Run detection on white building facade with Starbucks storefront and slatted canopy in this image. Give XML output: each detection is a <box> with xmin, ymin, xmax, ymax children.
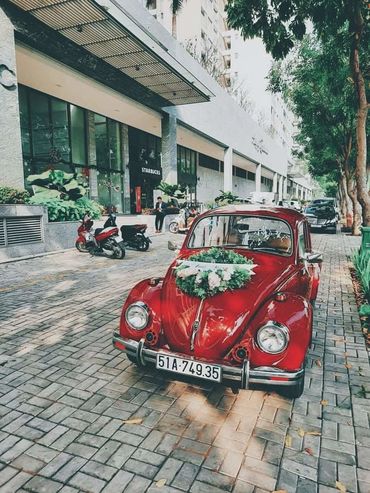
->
<box><xmin>0</xmin><ymin>0</ymin><xmax>312</xmax><ymax>213</ymax></box>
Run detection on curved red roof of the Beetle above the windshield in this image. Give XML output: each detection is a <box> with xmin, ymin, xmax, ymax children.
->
<box><xmin>202</xmin><ymin>204</ymin><xmax>305</xmax><ymax>226</ymax></box>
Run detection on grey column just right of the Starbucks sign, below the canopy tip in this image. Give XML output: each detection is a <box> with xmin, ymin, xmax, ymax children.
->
<box><xmin>162</xmin><ymin>113</ymin><xmax>177</xmax><ymax>185</ymax></box>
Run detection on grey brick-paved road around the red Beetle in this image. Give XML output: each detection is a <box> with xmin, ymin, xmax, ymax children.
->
<box><xmin>0</xmin><ymin>235</ymin><xmax>370</xmax><ymax>493</ymax></box>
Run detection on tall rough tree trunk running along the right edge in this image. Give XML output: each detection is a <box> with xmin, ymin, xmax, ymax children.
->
<box><xmin>349</xmin><ymin>0</ymin><xmax>370</xmax><ymax>226</ymax></box>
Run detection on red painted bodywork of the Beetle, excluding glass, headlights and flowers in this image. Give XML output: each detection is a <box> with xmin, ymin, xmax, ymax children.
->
<box><xmin>115</xmin><ymin>206</ymin><xmax>320</xmax><ymax>394</ymax></box>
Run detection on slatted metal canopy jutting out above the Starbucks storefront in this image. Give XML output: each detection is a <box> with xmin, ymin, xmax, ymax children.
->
<box><xmin>10</xmin><ymin>0</ymin><xmax>211</xmax><ymax>105</ymax></box>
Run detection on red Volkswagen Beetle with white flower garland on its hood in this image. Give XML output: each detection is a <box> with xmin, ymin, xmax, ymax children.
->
<box><xmin>113</xmin><ymin>205</ymin><xmax>322</xmax><ymax>397</ymax></box>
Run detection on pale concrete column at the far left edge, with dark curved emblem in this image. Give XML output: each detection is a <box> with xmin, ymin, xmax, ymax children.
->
<box><xmin>0</xmin><ymin>8</ymin><xmax>24</xmax><ymax>189</ymax></box>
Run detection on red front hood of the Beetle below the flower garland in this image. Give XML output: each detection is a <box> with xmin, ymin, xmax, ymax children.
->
<box><xmin>161</xmin><ymin>254</ymin><xmax>294</xmax><ymax>360</ymax></box>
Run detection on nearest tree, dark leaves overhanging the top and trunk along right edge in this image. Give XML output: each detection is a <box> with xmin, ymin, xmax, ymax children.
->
<box><xmin>226</xmin><ymin>0</ymin><xmax>370</xmax><ymax>226</ymax></box>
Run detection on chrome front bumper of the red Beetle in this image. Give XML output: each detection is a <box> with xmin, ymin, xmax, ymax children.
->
<box><xmin>113</xmin><ymin>332</ymin><xmax>304</xmax><ymax>389</ymax></box>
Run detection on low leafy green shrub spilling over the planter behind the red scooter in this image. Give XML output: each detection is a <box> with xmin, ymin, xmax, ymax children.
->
<box><xmin>30</xmin><ymin>194</ymin><xmax>104</xmax><ymax>222</ymax></box>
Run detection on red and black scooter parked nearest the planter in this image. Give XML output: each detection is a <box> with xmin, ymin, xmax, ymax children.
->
<box><xmin>75</xmin><ymin>214</ymin><xmax>125</xmax><ymax>259</ymax></box>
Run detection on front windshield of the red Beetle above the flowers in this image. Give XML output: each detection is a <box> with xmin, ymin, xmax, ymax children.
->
<box><xmin>188</xmin><ymin>214</ymin><xmax>293</xmax><ymax>255</ymax></box>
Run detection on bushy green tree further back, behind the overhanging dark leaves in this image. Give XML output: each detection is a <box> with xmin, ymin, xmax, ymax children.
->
<box><xmin>269</xmin><ymin>33</ymin><xmax>361</xmax><ymax>234</ymax></box>
